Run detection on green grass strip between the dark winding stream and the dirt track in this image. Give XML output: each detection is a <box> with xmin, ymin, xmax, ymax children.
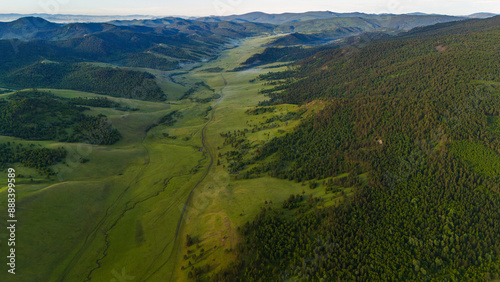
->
<box><xmin>65</xmin><ymin>140</ymin><xmax>208</xmax><ymax>280</ymax></box>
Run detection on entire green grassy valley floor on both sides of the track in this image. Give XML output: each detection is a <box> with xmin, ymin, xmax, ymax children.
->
<box><xmin>0</xmin><ymin>34</ymin><xmax>349</xmax><ymax>281</ymax></box>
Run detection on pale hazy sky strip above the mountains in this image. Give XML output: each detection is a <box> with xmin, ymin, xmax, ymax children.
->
<box><xmin>0</xmin><ymin>0</ymin><xmax>500</xmax><ymax>16</ymax></box>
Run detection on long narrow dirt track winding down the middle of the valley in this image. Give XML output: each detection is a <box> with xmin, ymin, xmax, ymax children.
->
<box><xmin>143</xmin><ymin>73</ymin><xmax>227</xmax><ymax>281</ymax></box>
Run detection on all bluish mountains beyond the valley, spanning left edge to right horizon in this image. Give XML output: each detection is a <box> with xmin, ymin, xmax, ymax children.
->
<box><xmin>0</xmin><ymin>11</ymin><xmax>496</xmax><ymax>97</ymax></box>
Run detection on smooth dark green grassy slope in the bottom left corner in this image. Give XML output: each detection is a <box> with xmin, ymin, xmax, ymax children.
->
<box><xmin>0</xmin><ymin>182</ymin><xmax>106</xmax><ymax>281</ymax></box>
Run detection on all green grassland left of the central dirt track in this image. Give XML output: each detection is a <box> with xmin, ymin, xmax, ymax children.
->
<box><xmin>0</xmin><ymin>81</ymin><xmax>207</xmax><ymax>281</ymax></box>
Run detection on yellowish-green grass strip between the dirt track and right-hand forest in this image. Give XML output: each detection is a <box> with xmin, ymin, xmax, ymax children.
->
<box><xmin>172</xmin><ymin>38</ymin><xmax>351</xmax><ymax>281</ymax></box>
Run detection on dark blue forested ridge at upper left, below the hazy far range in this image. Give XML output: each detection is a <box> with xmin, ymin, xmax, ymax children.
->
<box><xmin>1</xmin><ymin>19</ymin><xmax>228</xmax><ymax>65</ymax></box>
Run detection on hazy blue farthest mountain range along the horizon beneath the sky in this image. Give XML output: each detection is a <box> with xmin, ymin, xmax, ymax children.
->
<box><xmin>0</xmin><ymin>11</ymin><xmax>476</xmax><ymax>42</ymax></box>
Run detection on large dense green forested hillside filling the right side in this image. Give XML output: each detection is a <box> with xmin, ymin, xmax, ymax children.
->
<box><xmin>215</xmin><ymin>17</ymin><xmax>500</xmax><ymax>281</ymax></box>
